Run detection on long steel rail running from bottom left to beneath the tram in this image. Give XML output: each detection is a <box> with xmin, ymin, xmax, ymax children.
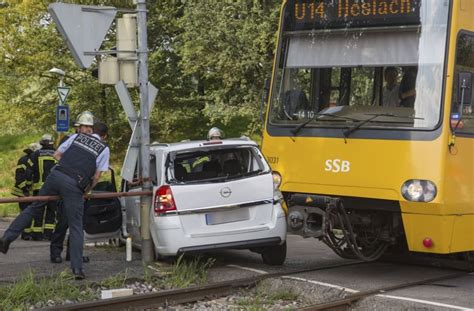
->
<box><xmin>44</xmin><ymin>261</ymin><xmax>367</xmax><ymax>311</ymax></box>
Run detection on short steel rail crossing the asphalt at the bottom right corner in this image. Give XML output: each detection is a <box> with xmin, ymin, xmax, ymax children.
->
<box><xmin>298</xmin><ymin>272</ymin><xmax>468</xmax><ymax>311</ymax></box>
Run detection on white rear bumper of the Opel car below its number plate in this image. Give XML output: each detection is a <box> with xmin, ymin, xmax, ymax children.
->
<box><xmin>150</xmin><ymin>203</ymin><xmax>286</xmax><ymax>256</ymax></box>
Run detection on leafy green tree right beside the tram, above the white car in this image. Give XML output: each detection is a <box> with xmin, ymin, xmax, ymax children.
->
<box><xmin>177</xmin><ymin>0</ymin><xmax>278</xmax><ymax>136</ymax></box>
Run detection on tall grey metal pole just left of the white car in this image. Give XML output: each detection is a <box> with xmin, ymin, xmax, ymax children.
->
<box><xmin>136</xmin><ymin>0</ymin><xmax>154</xmax><ymax>263</ymax></box>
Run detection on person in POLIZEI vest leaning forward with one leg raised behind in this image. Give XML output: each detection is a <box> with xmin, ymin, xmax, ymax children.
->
<box><xmin>0</xmin><ymin>113</ymin><xmax>110</xmax><ymax>280</ymax></box>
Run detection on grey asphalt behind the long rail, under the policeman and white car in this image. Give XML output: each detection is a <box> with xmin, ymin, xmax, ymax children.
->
<box><xmin>0</xmin><ymin>218</ymin><xmax>343</xmax><ymax>286</ymax></box>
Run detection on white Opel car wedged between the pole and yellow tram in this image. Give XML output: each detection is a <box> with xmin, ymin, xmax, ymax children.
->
<box><xmin>122</xmin><ymin>138</ymin><xmax>286</xmax><ymax>265</ymax></box>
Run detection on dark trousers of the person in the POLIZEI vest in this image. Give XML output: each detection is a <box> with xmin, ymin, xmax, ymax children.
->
<box><xmin>3</xmin><ymin>170</ymin><xmax>84</xmax><ymax>269</ymax></box>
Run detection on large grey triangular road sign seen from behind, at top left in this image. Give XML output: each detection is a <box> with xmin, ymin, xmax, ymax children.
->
<box><xmin>48</xmin><ymin>3</ymin><xmax>117</xmax><ymax>68</ymax></box>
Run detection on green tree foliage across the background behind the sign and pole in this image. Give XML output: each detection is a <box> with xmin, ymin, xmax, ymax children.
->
<box><xmin>0</xmin><ymin>0</ymin><xmax>280</xmax><ymax>147</ymax></box>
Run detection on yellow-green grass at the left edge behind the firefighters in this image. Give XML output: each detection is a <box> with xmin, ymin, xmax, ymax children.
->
<box><xmin>0</xmin><ymin>134</ymin><xmax>41</xmax><ymax>217</ymax></box>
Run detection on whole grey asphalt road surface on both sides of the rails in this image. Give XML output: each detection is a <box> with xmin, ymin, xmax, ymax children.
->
<box><xmin>0</xmin><ymin>219</ymin><xmax>474</xmax><ymax>310</ymax></box>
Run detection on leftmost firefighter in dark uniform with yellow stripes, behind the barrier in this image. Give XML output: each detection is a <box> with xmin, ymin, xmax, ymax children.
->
<box><xmin>11</xmin><ymin>143</ymin><xmax>41</xmax><ymax>240</ymax></box>
